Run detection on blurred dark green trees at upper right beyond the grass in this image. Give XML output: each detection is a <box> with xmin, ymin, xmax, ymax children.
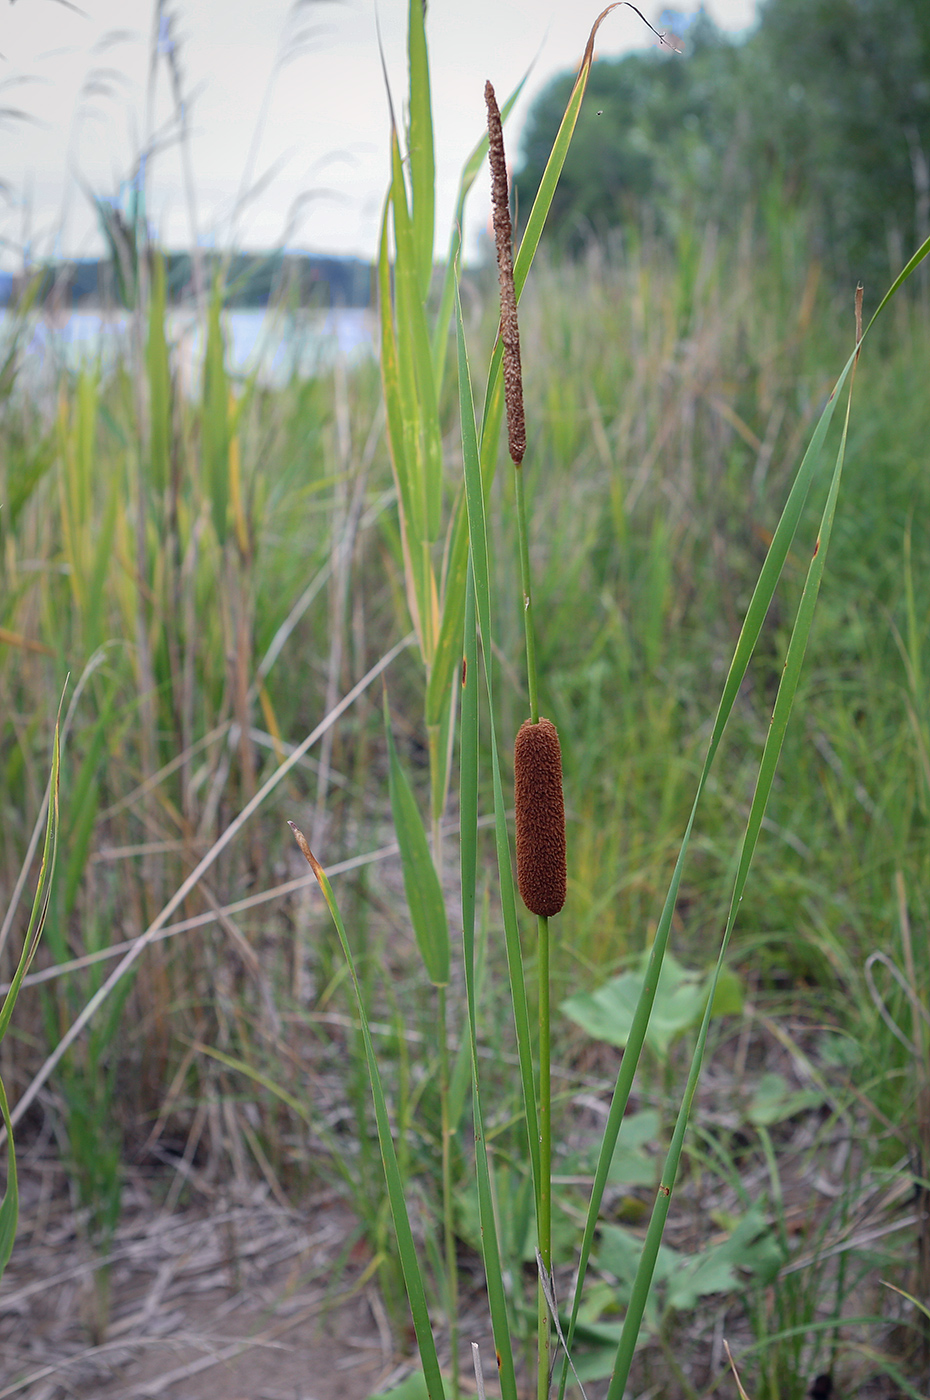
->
<box><xmin>515</xmin><ymin>0</ymin><xmax>930</xmax><ymax>279</ymax></box>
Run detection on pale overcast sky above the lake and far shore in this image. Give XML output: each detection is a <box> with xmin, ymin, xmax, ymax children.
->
<box><xmin>0</xmin><ymin>0</ymin><xmax>756</xmax><ymax>269</ymax></box>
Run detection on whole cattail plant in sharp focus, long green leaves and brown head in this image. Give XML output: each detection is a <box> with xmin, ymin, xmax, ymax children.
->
<box><xmin>291</xmin><ymin>0</ymin><xmax>930</xmax><ymax>1400</ymax></box>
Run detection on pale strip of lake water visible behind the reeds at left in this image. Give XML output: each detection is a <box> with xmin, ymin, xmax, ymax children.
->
<box><xmin>0</xmin><ymin>307</ymin><xmax>375</xmax><ymax>393</ymax></box>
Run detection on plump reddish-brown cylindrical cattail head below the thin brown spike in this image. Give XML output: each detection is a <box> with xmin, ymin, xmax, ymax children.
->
<box><xmin>514</xmin><ymin>718</ymin><xmax>566</xmax><ymax>918</ymax></box>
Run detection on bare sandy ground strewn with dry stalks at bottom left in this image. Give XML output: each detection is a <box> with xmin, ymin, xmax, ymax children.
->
<box><xmin>0</xmin><ymin>1162</ymin><xmax>409</xmax><ymax>1400</ymax></box>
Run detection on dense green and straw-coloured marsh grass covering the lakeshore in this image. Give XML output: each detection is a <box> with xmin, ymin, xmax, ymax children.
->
<box><xmin>0</xmin><ymin>3</ymin><xmax>930</xmax><ymax>1396</ymax></box>
